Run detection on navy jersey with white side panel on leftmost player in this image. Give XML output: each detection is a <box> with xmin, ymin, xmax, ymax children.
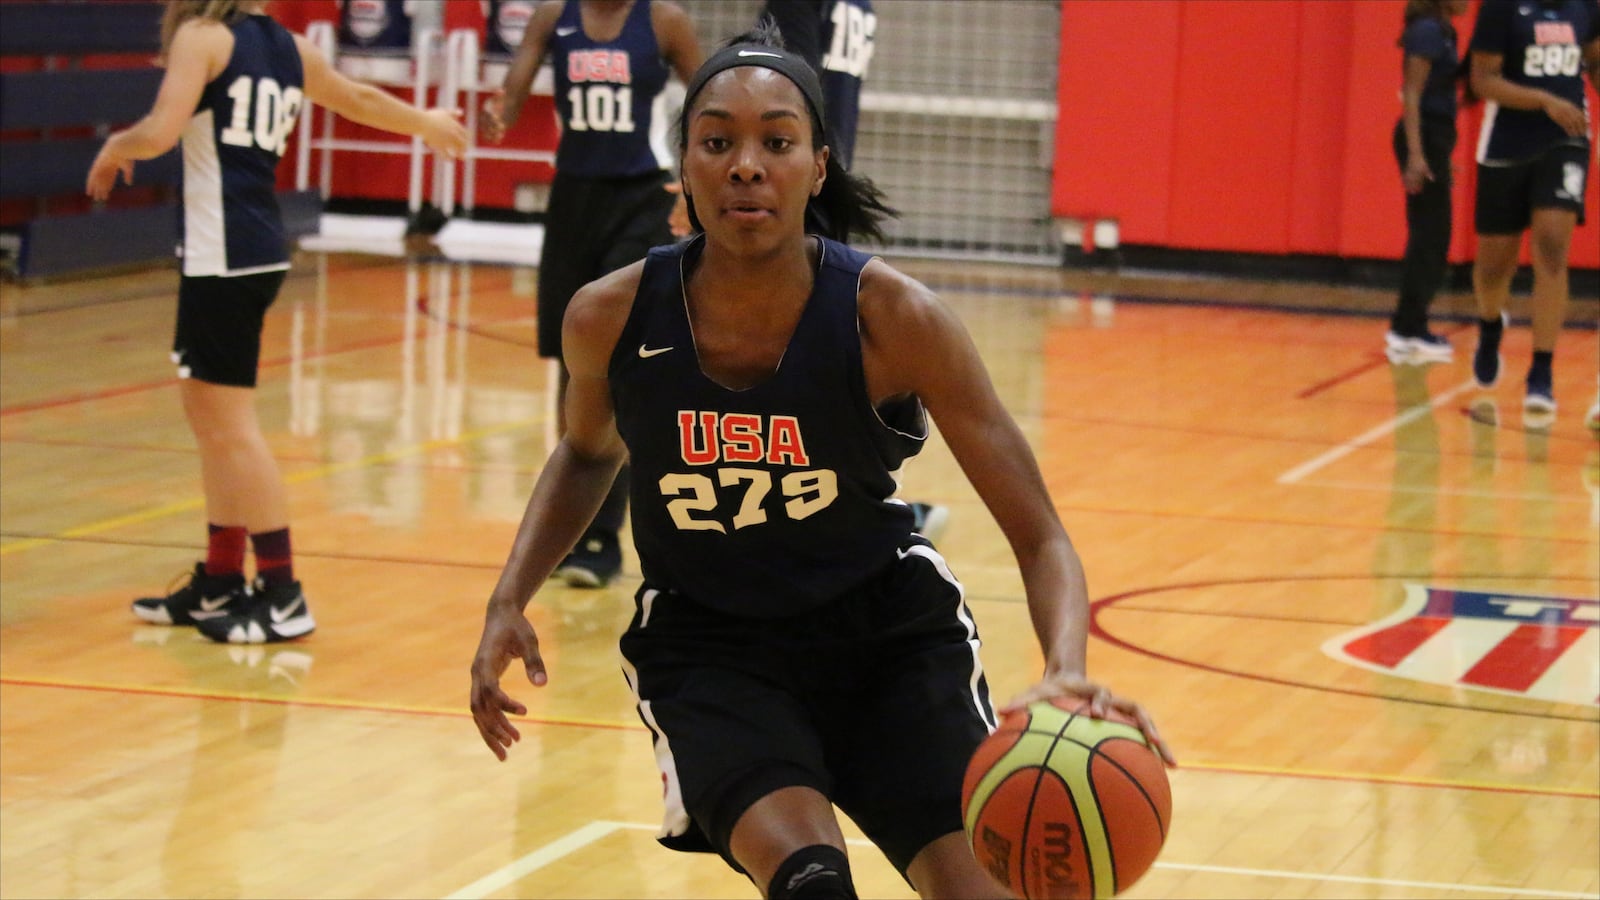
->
<box><xmin>182</xmin><ymin>16</ymin><xmax>306</xmax><ymax>275</ymax></box>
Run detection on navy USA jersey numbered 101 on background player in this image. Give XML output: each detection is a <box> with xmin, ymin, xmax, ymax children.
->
<box><xmin>550</xmin><ymin>0</ymin><xmax>672</xmax><ymax>178</ymax></box>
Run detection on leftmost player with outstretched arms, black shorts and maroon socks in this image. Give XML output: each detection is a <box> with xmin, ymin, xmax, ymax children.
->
<box><xmin>86</xmin><ymin>0</ymin><xmax>467</xmax><ymax>644</ymax></box>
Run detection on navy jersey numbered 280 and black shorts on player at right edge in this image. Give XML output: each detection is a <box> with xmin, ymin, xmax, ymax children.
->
<box><xmin>1470</xmin><ymin>0</ymin><xmax>1600</xmax><ymax>234</ymax></box>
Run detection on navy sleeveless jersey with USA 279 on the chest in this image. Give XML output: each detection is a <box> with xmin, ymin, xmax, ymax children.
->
<box><xmin>610</xmin><ymin>237</ymin><xmax>928</xmax><ymax>618</ymax></box>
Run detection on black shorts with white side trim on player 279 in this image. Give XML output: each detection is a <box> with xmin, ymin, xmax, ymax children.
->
<box><xmin>621</xmin><ymin>536</ymin><xmax>995</xmax><ymax>874</ymax></box>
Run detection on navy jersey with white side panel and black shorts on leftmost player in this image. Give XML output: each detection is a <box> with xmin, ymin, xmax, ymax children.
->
<box><xmin>173</xmin><ymin>16</ymin><xmax>306</xmax><ymax>386</ymax></box>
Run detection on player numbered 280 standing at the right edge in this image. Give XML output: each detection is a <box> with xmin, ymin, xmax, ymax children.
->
<box><xmin>1470</xmin><ymin>0</ymin><xmax>1600</xmax><ymax>424</ymax></box>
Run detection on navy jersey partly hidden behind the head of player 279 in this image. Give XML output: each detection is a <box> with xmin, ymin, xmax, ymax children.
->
<box><xmin>766</xmin><ymin>0</ymin><xmax>878</xmax><ymax>168</ymax></box>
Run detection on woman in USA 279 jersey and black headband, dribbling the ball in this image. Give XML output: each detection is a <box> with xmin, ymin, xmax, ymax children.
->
<box><xmin>472</xmin><ymin>30</ymin><xmax>1166</xmax><ymax>898</ymax></box>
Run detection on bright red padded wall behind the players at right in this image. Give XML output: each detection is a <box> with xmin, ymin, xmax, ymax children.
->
<box><xmin>1051</xmin><ymin>0</ymin><xmax>1600</xmax><ymax>269</ymax></box>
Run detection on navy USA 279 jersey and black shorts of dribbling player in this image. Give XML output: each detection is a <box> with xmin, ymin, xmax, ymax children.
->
<box><xmin>610</xmin><ymin>237</ymin><xmax>994</xmax><ymax>871</ymax></box>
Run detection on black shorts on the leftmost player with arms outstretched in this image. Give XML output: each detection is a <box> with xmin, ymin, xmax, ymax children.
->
<box><xmin>173</xmin><ymin>269</ymin><xmax>288</xmax><ymax>388</ymax></box>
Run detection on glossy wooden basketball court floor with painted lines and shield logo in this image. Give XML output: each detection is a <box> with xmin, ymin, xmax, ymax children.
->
<box><xmin>0</xmin><ymin>246</ymin><xmax>1600</xmax><ymax>898</ymax></box>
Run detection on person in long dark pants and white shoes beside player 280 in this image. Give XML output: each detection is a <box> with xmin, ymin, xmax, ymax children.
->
<box><xmin>1384</xmin><ymin>0</ymin><xmax>1467</xmax><ymax>362</ymax></box>
